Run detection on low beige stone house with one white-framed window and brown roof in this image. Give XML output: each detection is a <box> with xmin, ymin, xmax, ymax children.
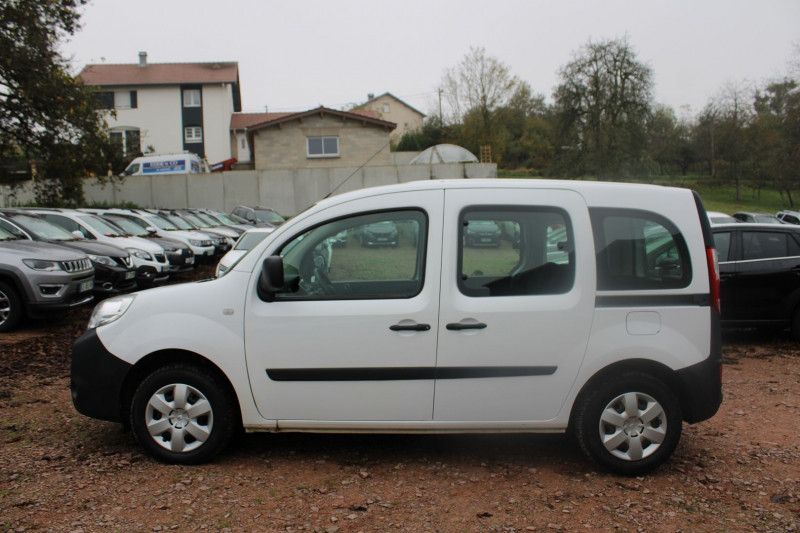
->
<box><xmin>231</xmin><ymin>107</ymin><xmax>397</xmax><ymax>170</ymax></box>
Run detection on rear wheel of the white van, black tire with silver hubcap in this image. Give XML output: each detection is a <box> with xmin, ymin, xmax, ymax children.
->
<box><xmin>574</xmin><ymin>372</ymin><xmax>682</xmax><ymax>476</ymax></box>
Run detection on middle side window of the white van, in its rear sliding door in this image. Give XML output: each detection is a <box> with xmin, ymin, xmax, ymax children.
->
<box><xmin>458</xmin><ymin>206</ymin><xmax>575</xmax><ymax>297</ymax></box>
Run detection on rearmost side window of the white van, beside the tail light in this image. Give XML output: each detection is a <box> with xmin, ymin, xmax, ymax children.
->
<box><xmin>591</xmin><ymin>209</ymin><xmax>692</xmax><ymax>290</ymax></box>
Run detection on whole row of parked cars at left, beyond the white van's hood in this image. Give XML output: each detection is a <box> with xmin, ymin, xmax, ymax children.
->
<box><xmin>0</xmin><ymin>208</ymin><xmax>282</xmax><ymax>332</ymax></box>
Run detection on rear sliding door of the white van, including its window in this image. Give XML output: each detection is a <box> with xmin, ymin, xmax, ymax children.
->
<box><xmin>434</xmin><ymin>189</ymin><xmax>595</xmax><ymax>427</ymax></box>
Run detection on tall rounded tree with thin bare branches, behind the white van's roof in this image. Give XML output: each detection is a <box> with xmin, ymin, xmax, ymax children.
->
<box><xmin>554</xmin><ymin>38</ymin><xmax>653</xmax><ymax>176</ymax></box>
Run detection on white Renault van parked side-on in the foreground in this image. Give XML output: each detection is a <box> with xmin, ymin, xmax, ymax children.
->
<box><xmin>72</xmin><ymin>180</ymin><xmax>722</xmax><ymax>474</ymax></box>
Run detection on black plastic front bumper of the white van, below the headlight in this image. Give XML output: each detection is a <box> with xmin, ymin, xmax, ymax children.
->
<box><xmin>70</xmin><ymin>329</ymin><xmax>132</xmax><ymax>422</ymax></box>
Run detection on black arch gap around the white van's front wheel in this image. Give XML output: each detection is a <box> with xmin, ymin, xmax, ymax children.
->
<box><xmin>119</xmin><ymin>349</ymin><xmax>242</xmax><ymax>426</ymax></box>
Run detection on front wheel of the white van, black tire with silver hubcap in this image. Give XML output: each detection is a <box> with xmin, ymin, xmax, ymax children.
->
<box><xmin>130</xmin><ymin>364</ymin><xmax>238</xmax><ymax>465</ymax></box>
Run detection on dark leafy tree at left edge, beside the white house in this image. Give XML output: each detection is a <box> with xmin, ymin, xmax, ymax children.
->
<box><xmin>0</xmin><ymin>0</ymin><xmax>121</xmax><ymax>203</ymax></box>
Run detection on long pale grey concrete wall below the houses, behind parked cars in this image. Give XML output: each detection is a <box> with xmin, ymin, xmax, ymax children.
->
<box><xmin>0</xmin><ymin>163</ymin><xmax>497</xmax><ymax>216</ymax></box>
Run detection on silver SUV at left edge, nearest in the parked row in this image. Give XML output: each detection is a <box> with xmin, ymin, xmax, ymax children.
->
<box><xmin>0</xmin><ymin>225</ymin><xmax>94</xmax><ymax>333</ymax></box>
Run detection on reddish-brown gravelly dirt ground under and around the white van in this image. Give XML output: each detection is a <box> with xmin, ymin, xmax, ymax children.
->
<box><xmin>0</xmin><ymin>268</ymin><xmax>800</xmax><ymax>533</ymax></box>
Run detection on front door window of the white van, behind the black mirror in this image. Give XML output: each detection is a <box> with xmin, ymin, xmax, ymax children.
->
<box><xmin>276</xmin><ymin>210</ymin><xmax>427</xmax><ymax>300</ymax></box>
